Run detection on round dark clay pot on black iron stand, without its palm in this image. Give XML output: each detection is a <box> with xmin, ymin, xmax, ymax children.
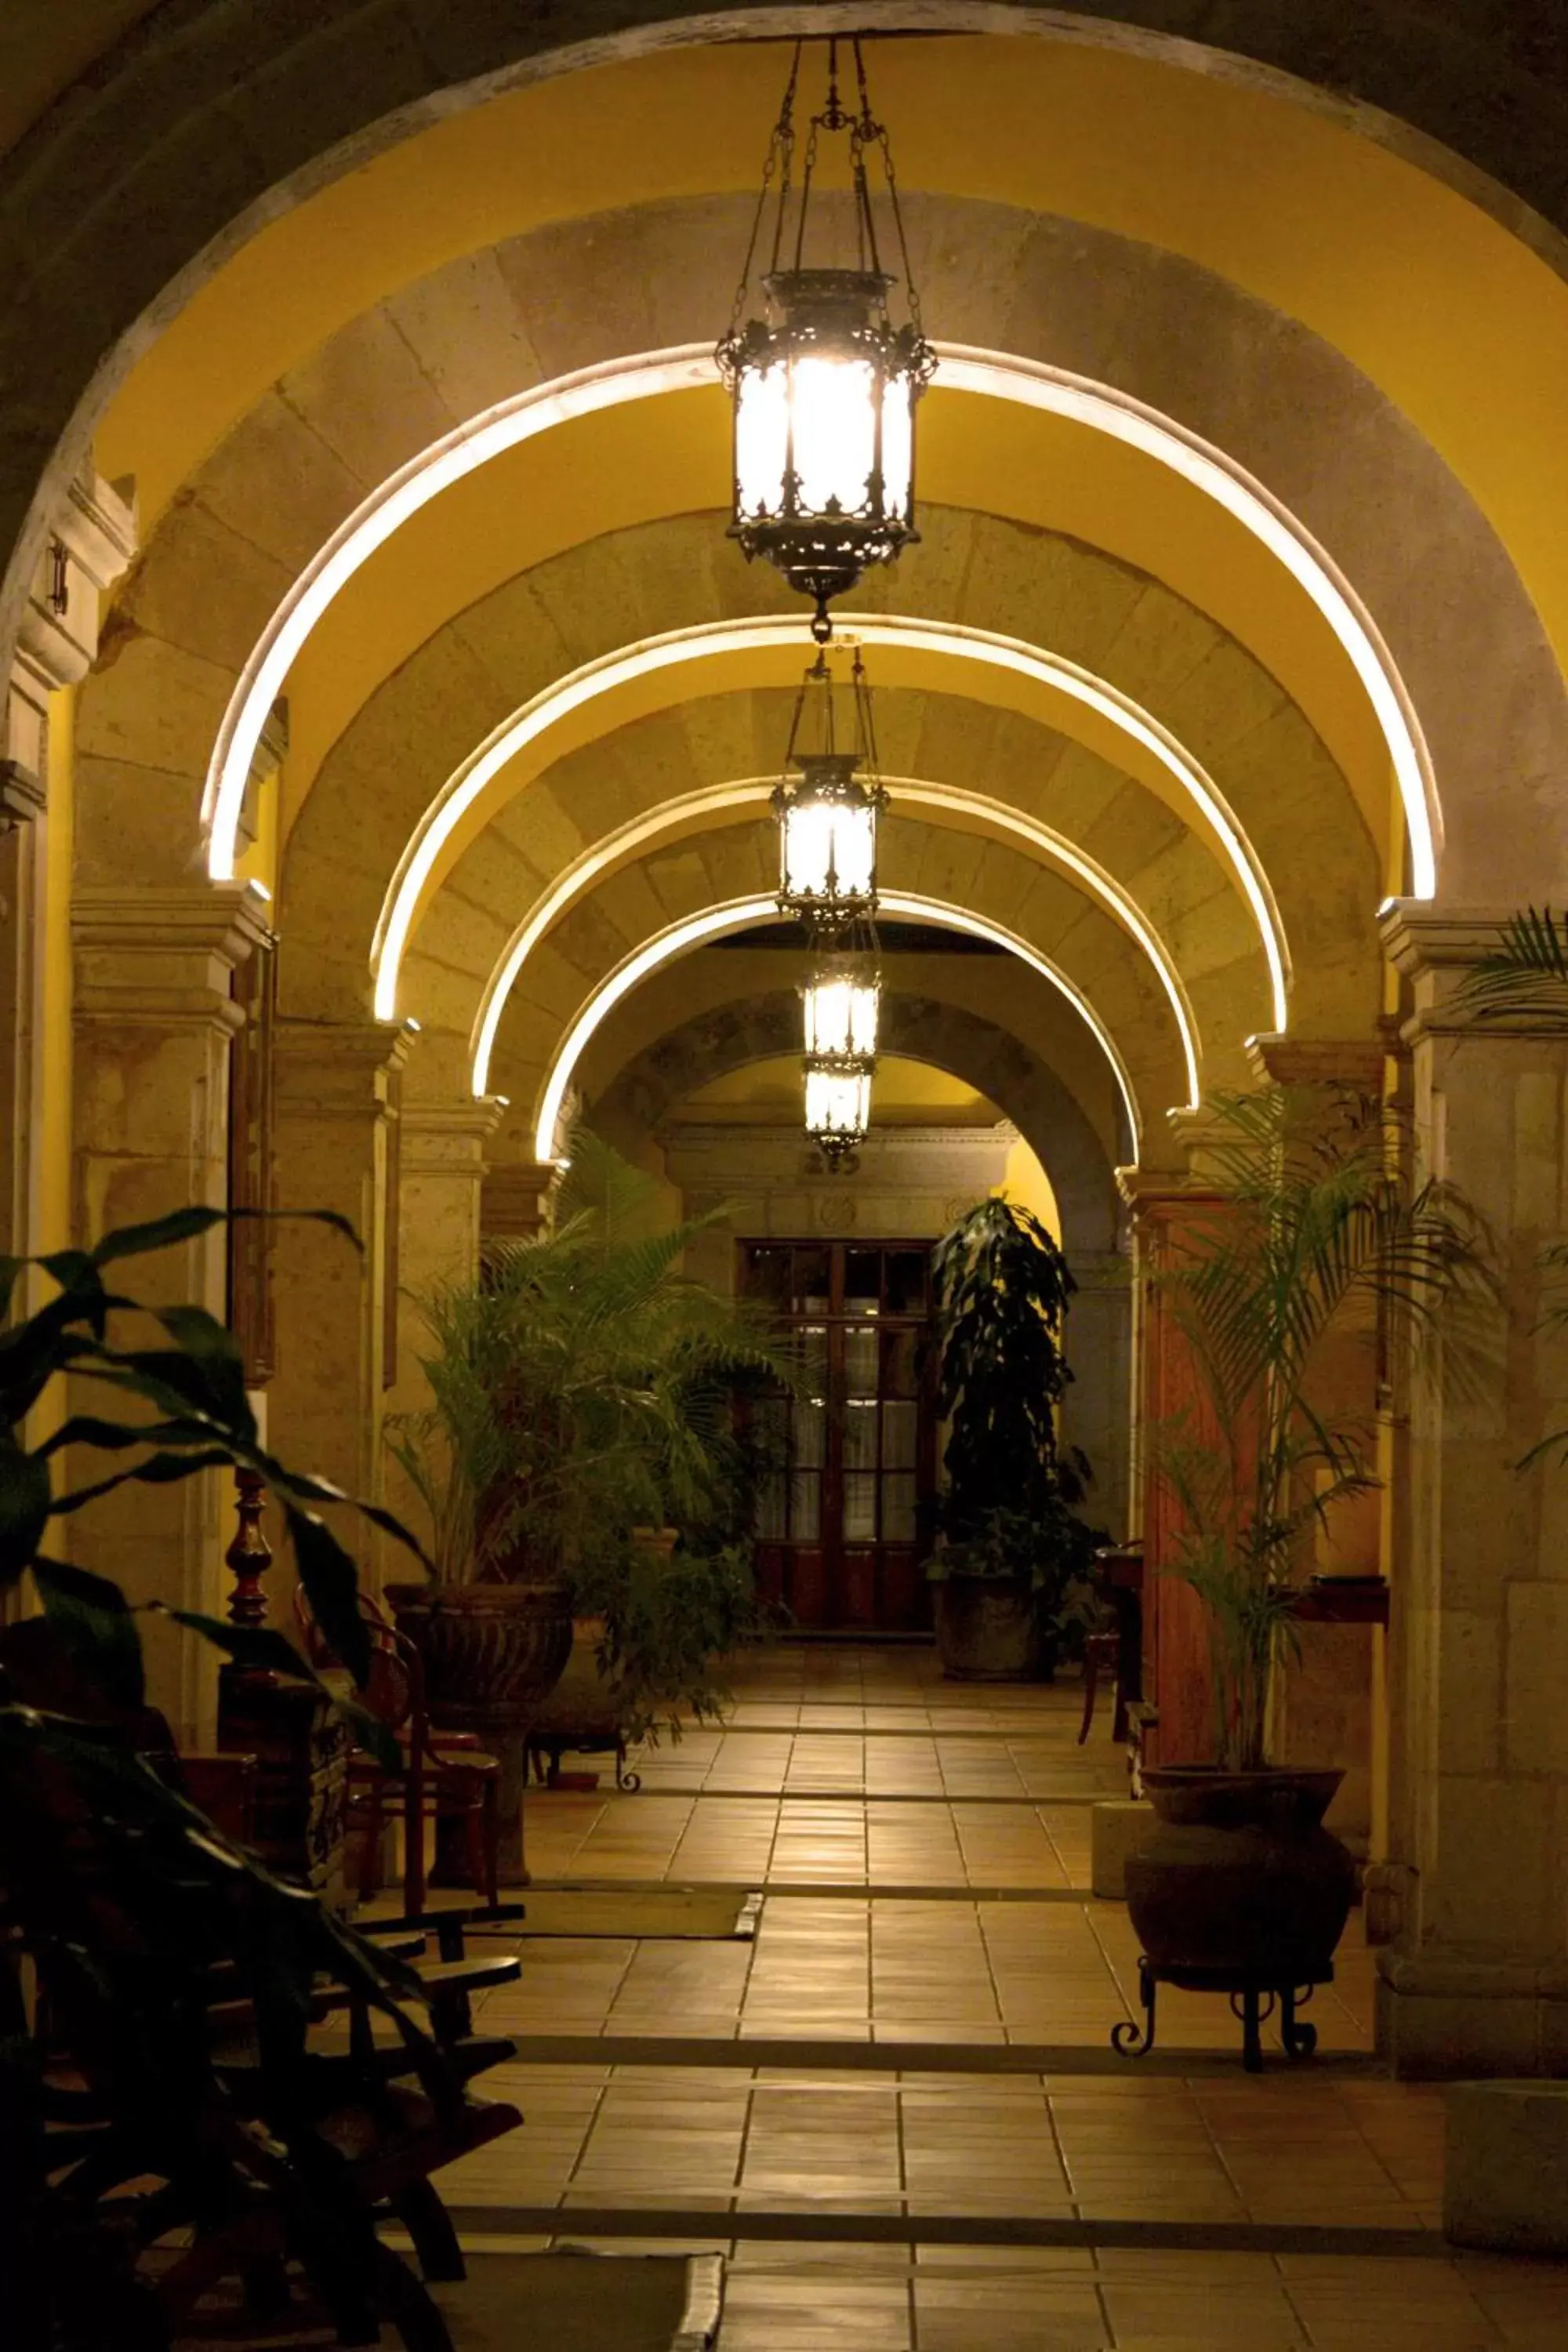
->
<box><xmin>1126</xmin><ymin>1764</ymin><xmax>1356</xmax><ymax>1987</ymax></box>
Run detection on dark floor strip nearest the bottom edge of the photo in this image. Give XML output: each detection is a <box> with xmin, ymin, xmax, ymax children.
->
<box><xmin>452</xmin><ymin>2206</ymin><xmax>1453</xmax><ymax>2260</ymax></box>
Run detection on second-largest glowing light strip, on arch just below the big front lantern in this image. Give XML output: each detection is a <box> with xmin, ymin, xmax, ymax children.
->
<box><xmin>372</xmin><ymin>614</ymin><xmax>1290</xmax><ymax>1030</ymax></box>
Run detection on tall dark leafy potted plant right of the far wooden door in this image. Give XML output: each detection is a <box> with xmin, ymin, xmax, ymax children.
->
<box><xmin>926</xmin><ymin>1200</ymin><xmax>1105</xmax><ymax>1682</ymax></box>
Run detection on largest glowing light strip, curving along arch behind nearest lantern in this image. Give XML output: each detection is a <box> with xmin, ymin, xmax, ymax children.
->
<box><xmin>202</xmin><ymin>343</ymin><xmax>1441</xmax><ymax>898</ymax></box>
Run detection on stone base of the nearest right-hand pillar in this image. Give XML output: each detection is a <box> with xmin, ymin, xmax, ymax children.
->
<box><xmin>1377</xmin><ymin>1950</ymin><xmax>1568</xmax><ymax>2082</ymax></box>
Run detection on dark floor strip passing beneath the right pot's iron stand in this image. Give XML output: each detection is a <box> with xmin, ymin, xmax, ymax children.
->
<box><xmin>493</xmin><ymin>2032</ymin><xmax>1385</xmax><ymax>2084</ymax></box>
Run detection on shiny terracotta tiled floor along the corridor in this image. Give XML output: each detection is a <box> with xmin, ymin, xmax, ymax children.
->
<box><xmin>423</xmin><ymin>1646</ymin><xmax>1568</xmax><ymax>2352</ymax></box>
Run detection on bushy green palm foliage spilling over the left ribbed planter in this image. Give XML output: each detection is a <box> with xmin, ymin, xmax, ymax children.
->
<box><xmin>388</xmin><ymin>1134</ymin><xmax>787</xmax><ymax>1790</ymax></box>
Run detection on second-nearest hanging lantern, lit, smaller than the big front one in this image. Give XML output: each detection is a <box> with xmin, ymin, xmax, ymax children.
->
<box><xmin>774</xmin><ymin>652</ymin><xmax>886</xmax><ymax>938</ymax></box>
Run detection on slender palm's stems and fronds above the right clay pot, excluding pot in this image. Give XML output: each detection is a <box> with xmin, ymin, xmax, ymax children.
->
<box><xmin>1149</xmin><ymin>1087</ymin><xmax>1493</xmax><ymax>1771</ymax></box>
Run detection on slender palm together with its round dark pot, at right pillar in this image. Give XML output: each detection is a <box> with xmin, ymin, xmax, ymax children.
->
<box><xmin>1126</xmin><ymin>1087</ymin><xmax>1488</xmax><ymax>1987</ymax></box>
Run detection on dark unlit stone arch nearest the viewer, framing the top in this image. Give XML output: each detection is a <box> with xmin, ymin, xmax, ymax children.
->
<box><xmin>0</xmin><ymin>0</ymin><xmax>1568</xmax><ymax>673</ymax></box>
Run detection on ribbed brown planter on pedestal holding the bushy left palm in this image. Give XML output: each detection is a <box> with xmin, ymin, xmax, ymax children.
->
<box><xmin>386</xmin><ymin>1583</ymin><xmax>572</xmax><ymax>1886</ymax></box>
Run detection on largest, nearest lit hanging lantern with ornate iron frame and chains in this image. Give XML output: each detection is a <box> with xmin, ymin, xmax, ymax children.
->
<box><xmin>717</xmin><ymin>40</ymin><xmax>935</xmax><ymax>642</ymax></box>
